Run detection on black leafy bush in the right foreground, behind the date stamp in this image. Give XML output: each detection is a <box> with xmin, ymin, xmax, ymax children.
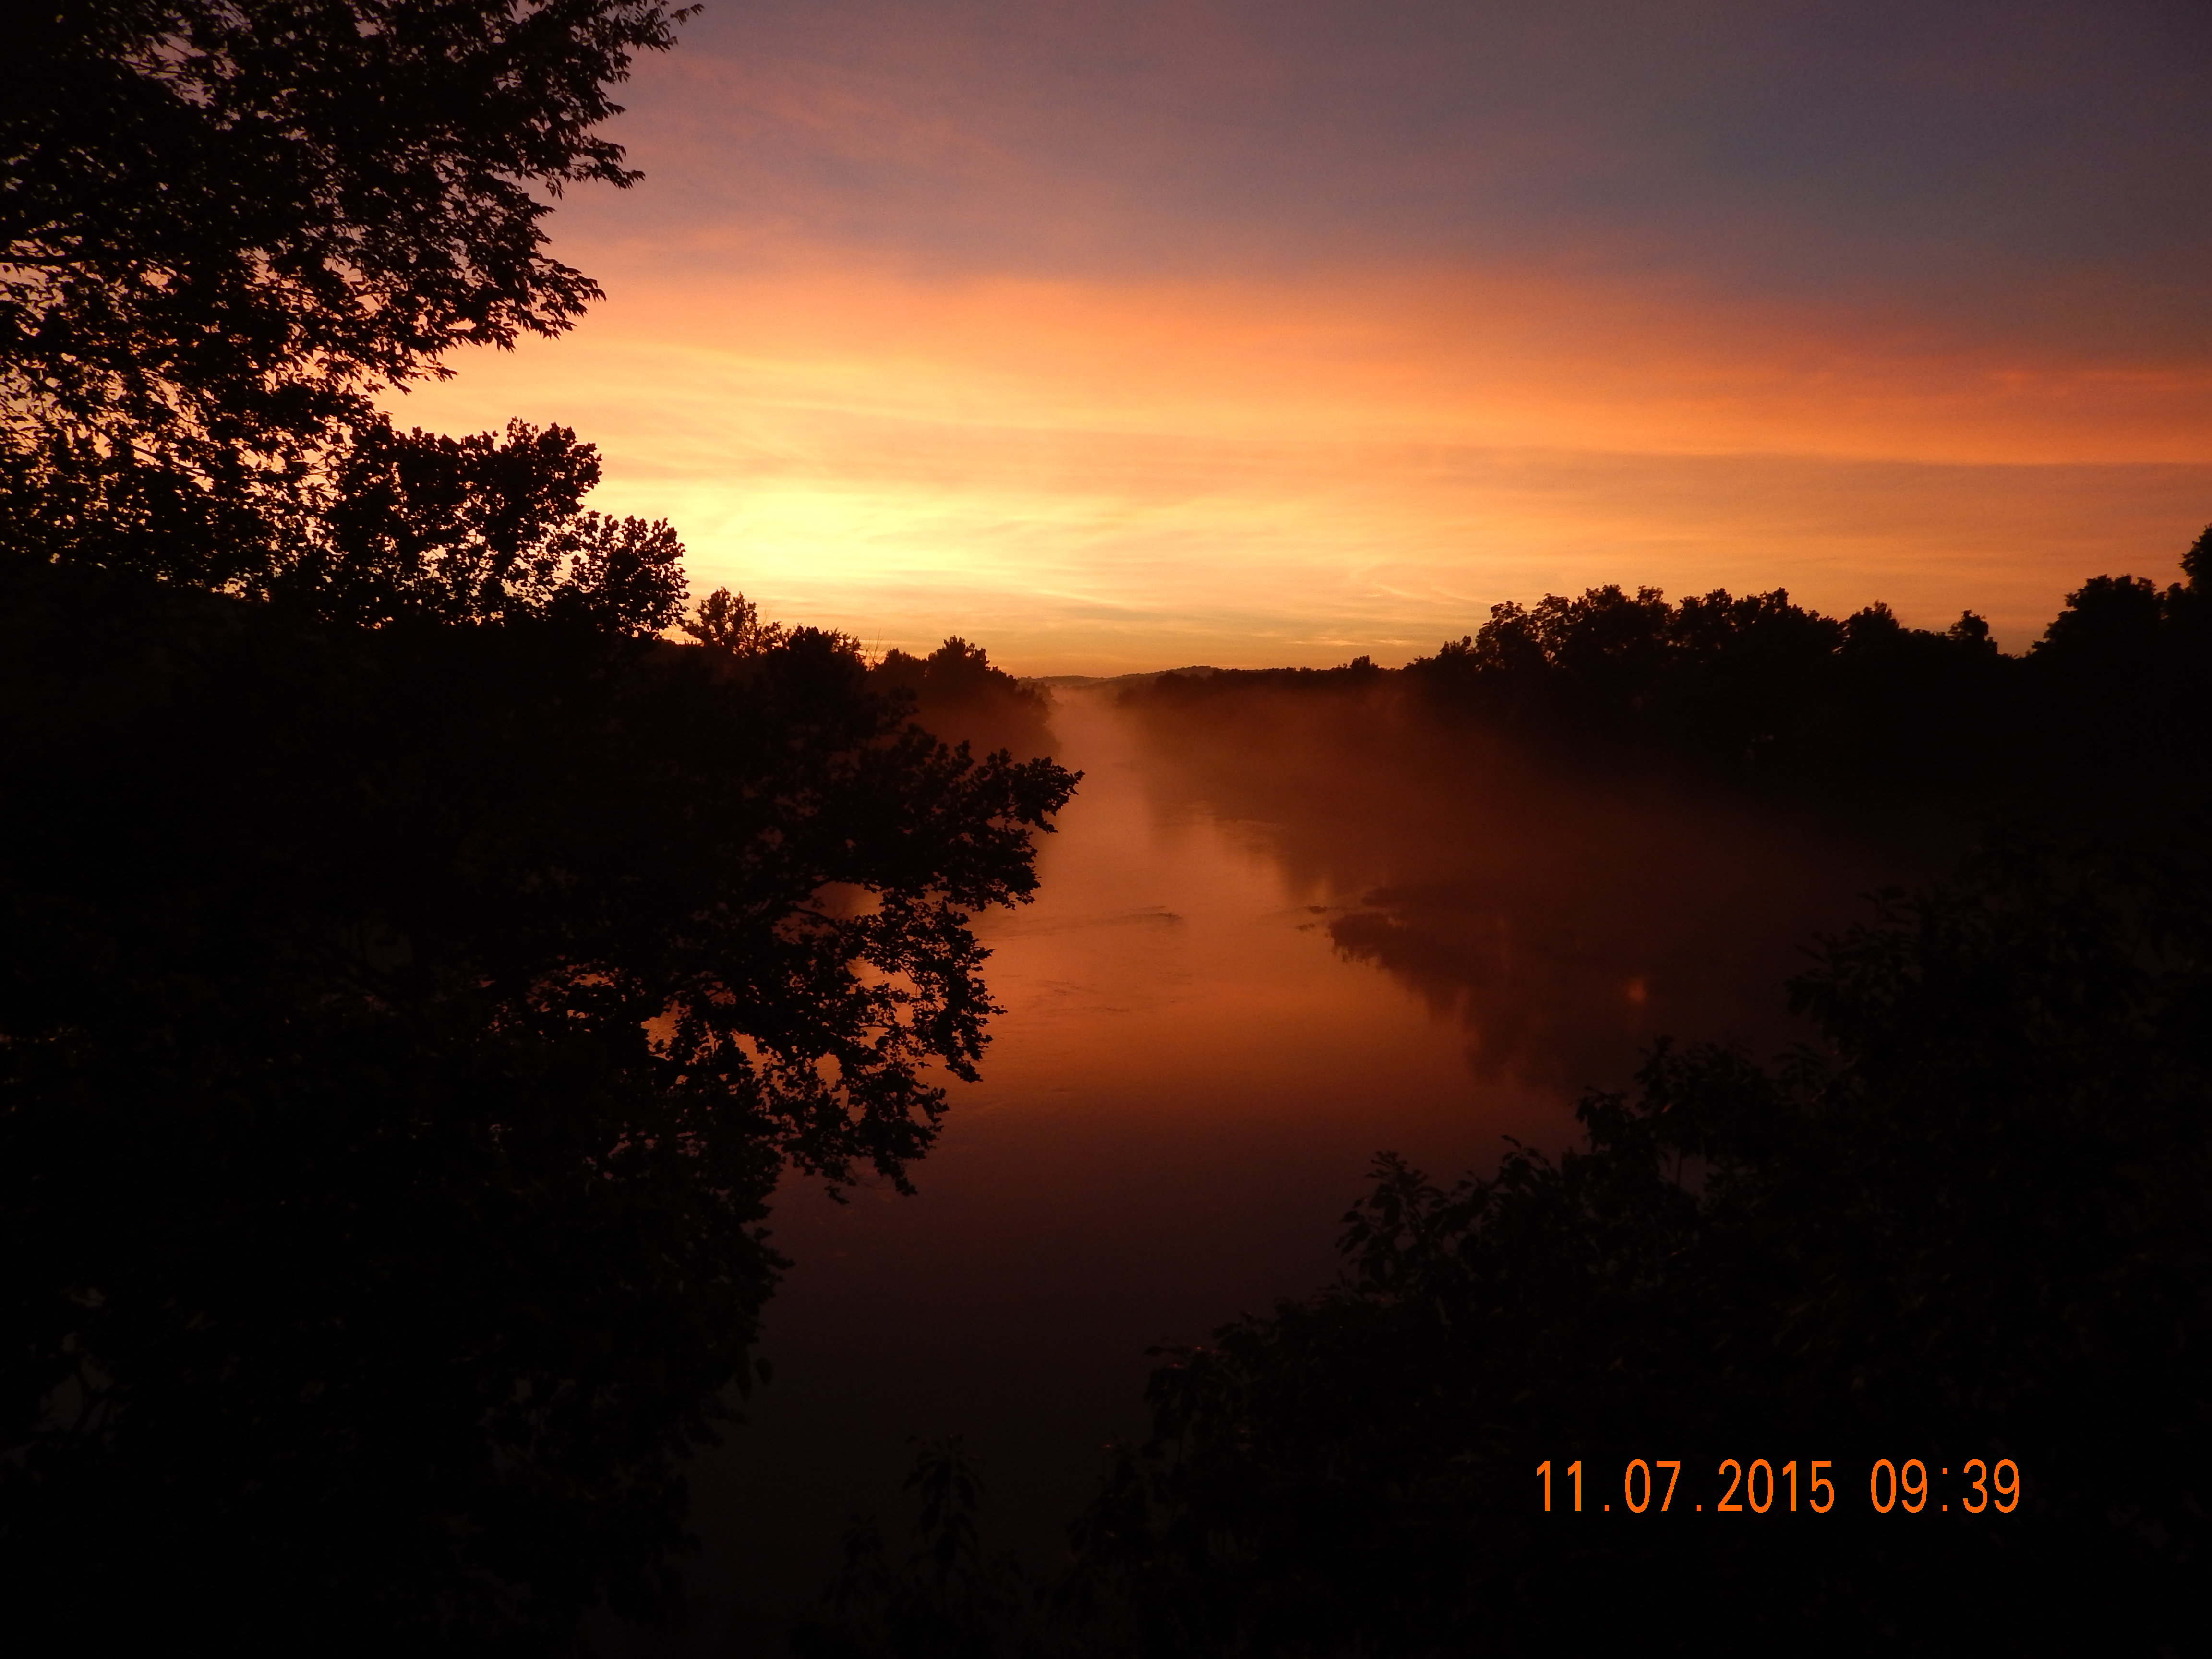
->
<box><xmin>1077</xmin><ymin>832</ymin><xmax>2212</xmax><ymax>1657</ymax></box>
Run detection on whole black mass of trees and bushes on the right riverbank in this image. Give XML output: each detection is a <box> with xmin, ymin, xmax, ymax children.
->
<box><xmin>796</xmin><ymin>570</ymin><xmax>2212</xmax><ymax>1659</ymax></box>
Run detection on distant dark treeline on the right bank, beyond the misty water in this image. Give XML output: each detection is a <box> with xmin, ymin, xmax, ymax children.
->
<box><xmin>1126</xmin><ymin>559</ymin><xmax>2212</xmax><ymax>807</ymax></box>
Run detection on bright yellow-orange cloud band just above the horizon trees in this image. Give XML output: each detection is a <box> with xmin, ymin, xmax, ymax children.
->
<box><xmin>398</xmin><ymin>261</ymin><xmax>2212</xmax><ymax>673</ymax></box>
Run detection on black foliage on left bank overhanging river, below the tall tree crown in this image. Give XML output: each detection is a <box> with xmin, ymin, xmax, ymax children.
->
<box><xmin>0</xmin><ymin>564</ymin><xmax>1070</xmax><ymax>1652</ymax></box>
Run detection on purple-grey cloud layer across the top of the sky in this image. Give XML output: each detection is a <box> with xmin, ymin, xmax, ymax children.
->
<box><xmin>588</xmin><ymin>0</ymin><xmax>2212</xmax><ymax>345</ymax></box>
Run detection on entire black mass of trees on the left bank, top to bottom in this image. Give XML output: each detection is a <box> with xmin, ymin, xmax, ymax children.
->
<box><xmin>0</xmin><ymin>0</ymin><xmax>1073</xmax><ymax>1655</ymax></box>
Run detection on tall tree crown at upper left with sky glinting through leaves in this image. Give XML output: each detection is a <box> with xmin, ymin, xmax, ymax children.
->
<box><xmin>0</xmin><ymin>0</ymin><xmax>684</xmax><ymax>589</ymax></box>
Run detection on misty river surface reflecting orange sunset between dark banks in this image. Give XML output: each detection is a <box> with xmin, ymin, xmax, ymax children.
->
<box><xmin>668</xmin><ymin>695</ymin><xmax>1937</xmax><ymax>1636</ymax></box>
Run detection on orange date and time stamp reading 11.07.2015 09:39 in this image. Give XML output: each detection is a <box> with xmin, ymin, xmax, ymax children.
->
<box><xmin>1535</xmin><ymin>1458</ymin><xmax>2020</xmax><ymax>1515</ymax></box>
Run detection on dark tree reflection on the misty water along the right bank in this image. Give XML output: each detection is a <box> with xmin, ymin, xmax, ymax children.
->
<box><xmin>1115</xmin><ymin>690</ymin><xmax>1955</xmax><ymax>1097</ymax></box>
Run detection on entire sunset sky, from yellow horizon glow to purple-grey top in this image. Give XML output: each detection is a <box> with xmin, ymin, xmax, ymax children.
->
<box><xmin>394</xmin><ymin>0</ymin><xmax>2212</xmax><ymax>674</ymax></box>
